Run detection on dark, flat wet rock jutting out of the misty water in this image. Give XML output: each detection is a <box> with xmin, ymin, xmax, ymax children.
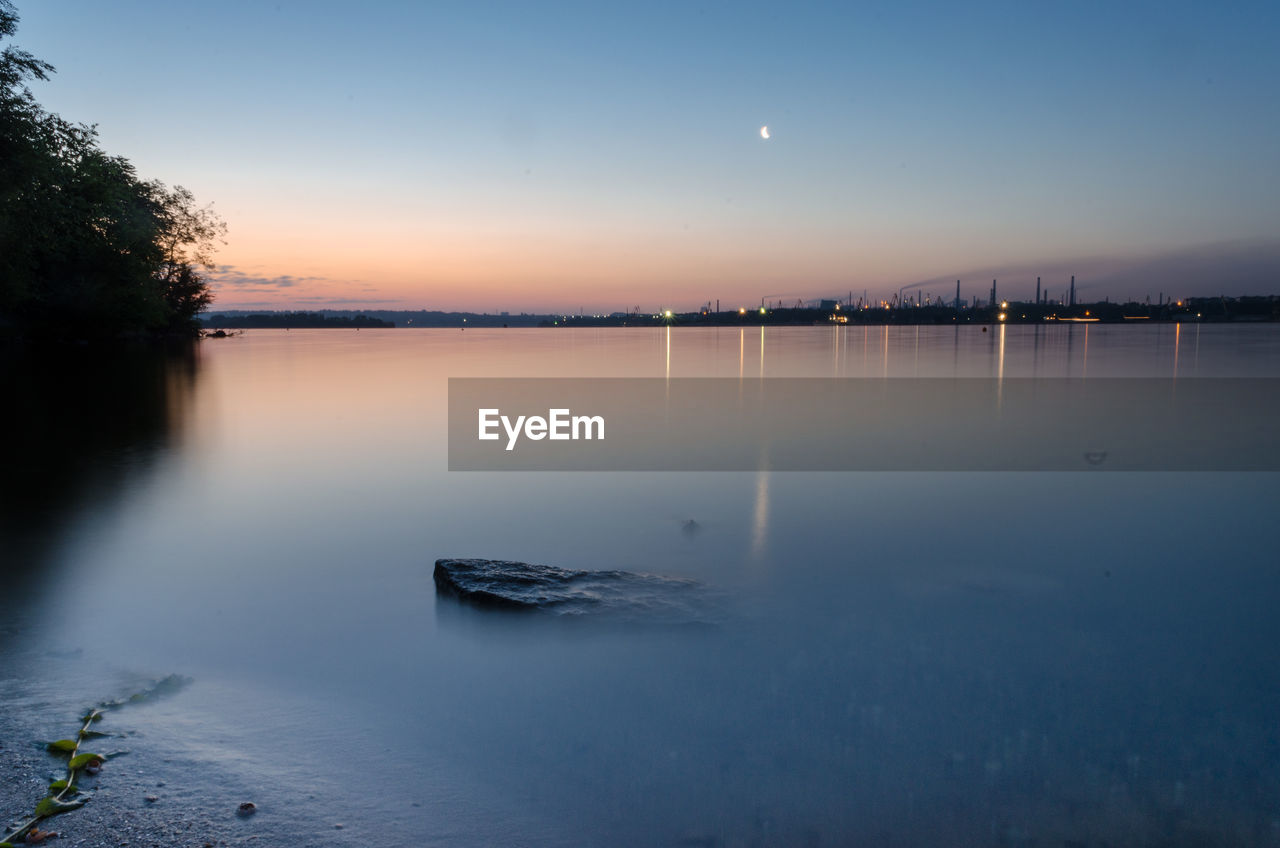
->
<box><xmin>435</xmin><ymin>560</ymin><xmax>705</xmax><ymax>623</ymax></box>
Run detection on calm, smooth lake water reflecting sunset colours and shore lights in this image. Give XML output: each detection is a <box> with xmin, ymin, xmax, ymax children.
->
<box><xmin>0</xmin><ymin>325</ymin><xmax>1280</xmax><ymax>847</ymax></box>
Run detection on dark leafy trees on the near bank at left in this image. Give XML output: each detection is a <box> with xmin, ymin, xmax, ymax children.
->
<box><xmin>0</xmin><ymin>0</ymin><xmax>225</xmax><ymax>338</ymax></box>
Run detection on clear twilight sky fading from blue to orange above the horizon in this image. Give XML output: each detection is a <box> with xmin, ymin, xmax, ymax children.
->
<box><xmin>13</xmin><ymin>0</ymin><xmax>1280</xmax><ymax>313</ymax></box>
